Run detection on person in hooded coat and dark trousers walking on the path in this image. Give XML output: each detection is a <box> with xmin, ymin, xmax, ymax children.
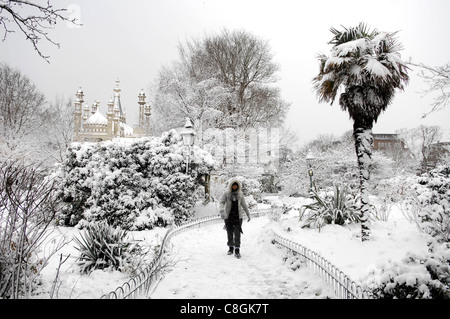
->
<box><xmin>219</xmin><ymin>178</ymin><xmax>250</xmax><ymax>258</ymax></box>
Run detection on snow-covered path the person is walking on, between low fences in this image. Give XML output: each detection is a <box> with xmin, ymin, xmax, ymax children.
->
<box><xmin>150</xmin><ymin>217</ymin><xmax>333</xmax><ymax>299</ymax></box>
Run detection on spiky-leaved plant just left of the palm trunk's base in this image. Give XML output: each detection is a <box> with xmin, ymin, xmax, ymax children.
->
<box><xmin>300</xmin><ymin>184</ymin><xmax>359</xmax><ymax>229</ymax></box>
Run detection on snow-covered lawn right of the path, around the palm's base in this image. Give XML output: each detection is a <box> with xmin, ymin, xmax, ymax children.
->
<box><xmin>266</xmin><ymin>198</ymin><xmax>430</xmax><ymax>282</ymax></box>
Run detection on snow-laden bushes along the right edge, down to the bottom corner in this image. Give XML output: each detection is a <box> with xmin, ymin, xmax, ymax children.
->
<box><xmin>366</xmin><ymin>165</ymin><xmax>450</xmax><ymax>299</ymax></box>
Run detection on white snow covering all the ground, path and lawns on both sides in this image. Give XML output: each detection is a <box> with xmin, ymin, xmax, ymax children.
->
<box><xmin>31</xmin><ymin>197</ymin><xmax>428</xmax><ymax>299</ymax></box>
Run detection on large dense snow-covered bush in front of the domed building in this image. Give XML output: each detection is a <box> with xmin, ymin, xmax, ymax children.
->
<box><xmin>53</xmin><ymin>130</ymin><xmax>216</xmax><ymax>230</ymax></box>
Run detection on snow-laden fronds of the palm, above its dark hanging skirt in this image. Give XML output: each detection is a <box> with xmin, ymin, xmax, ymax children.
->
<box><xmin>314</xmin><ymin>24</ymin><xmax>408</xmax><ymax>108</ymax></box>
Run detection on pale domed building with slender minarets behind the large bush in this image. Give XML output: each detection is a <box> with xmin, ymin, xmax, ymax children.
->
<box><xmin>73</xmin><ymin>80</ymin><xmax>151</xmax><ymax>142</ymax></box>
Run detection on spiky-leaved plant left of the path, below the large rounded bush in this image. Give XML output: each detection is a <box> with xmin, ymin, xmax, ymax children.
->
<box><xmin>74</xmin><ymin>222</ymin><xmax>142</xmax><ymax>274</ymax></box>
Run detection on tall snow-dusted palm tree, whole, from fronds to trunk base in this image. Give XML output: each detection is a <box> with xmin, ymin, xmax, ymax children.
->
<box><xmin>313</xmin><ymin>23</ymin><xmax>409</xmax><ymax>241</ymax></box>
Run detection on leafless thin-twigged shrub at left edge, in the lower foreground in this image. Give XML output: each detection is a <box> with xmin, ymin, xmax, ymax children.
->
<box><xmin>0</xmin><ymin>161</ymin><xmax>63</xmax><ymax>299</ymax></box>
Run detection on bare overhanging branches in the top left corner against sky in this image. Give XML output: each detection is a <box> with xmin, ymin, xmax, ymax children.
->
<box><xmin>0</xmin><ymin>0</ymin><xmax>79</xmax><ymax>62</ymax></box>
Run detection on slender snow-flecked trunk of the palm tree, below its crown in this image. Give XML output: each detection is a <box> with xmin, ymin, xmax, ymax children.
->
<box><xmin>353</xmin><ymin>122</ymin><xmax>373</xmax><ymax>241</ymax></box>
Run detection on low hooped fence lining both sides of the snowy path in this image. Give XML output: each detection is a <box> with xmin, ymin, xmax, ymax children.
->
<box><xmin>101</xmin><ymin>208</ymin><xmax>368</xmax><ymax>299</ymax></box>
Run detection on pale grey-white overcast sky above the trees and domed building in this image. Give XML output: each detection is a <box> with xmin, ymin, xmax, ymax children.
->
<box><xmin>0</xmin><ymin>0</ymin><xmax>450</xmax><ymax>143</ymax></box>
